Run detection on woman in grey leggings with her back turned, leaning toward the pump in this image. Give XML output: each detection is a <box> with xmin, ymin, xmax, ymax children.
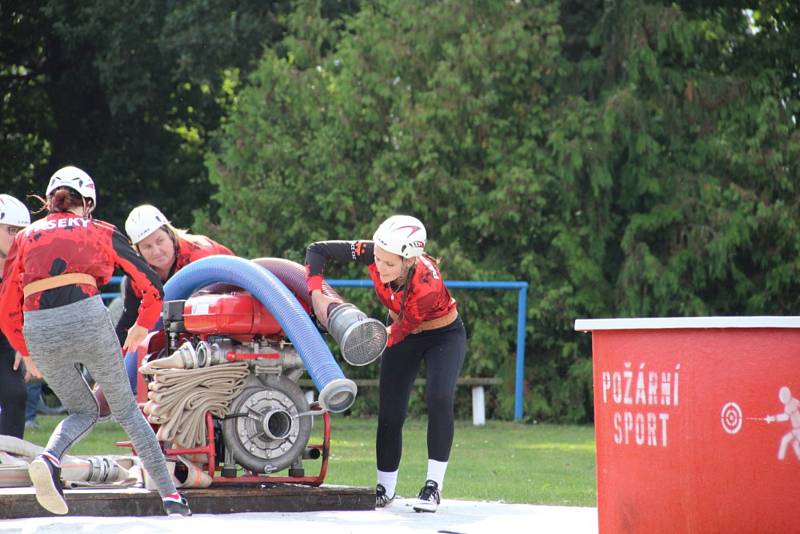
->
<box><xmin>0</xmin><ymin>167</ymin><xmax>191</xmax><ymax>515</ymax></box>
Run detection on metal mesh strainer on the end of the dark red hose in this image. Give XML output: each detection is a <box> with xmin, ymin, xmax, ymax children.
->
<box><xmin>328</xmin><ymin>303</ymin><xmax>389</xmax><ymax>366</ymax></box>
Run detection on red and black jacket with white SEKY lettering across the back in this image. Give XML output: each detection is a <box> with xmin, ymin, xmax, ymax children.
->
<box><xmin>0</xmin><ymin>213</ymin><xmax>164</xmax><ymax>355</ymax></box>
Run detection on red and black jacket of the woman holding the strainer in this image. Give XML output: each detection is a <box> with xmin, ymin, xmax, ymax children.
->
<box><xmin>306</xmin><ymin>241</ymin><xmax>456</xmax><ymax>347</ymax></box>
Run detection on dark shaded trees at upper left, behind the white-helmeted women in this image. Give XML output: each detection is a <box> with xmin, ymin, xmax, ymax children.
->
<box><xmin>0</xmin><ymin>0</ymin><xmax>290</xmax><ymax>225</ymax></box>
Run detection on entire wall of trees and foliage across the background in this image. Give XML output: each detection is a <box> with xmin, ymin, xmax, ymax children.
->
<box><xmin>0</xmin><ymin>0</ymin><xmax>800</xmax><ymax>422</ymax></box>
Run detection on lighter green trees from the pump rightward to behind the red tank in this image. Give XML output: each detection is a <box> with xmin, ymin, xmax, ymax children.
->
<box><xmin>208</xmin><ymin>0</ymin><xmax>800</xmax><ymax>421</ymax></box>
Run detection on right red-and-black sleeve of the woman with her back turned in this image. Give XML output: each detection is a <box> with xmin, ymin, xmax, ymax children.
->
<box><xmin>111</xmin><ymin>228</ymin><xmax>164</xmax><ymax>330</ymax></box>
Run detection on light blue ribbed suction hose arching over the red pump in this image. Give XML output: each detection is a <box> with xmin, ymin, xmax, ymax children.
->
<box><xmin>164</xmin><ymin>256</ymin><xmax>358</xmax><ymax>413</ymax></box>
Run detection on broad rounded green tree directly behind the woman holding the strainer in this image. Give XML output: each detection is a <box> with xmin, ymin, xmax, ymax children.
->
<box><xmin>203</xmin><ymin>2</ymin><xmax>562</xmax><ymax>420</ymax></box>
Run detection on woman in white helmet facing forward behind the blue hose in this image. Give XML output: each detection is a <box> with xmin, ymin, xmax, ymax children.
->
<box><xmin>116</xmin><ymin>204</ymin><xmax>233</xmax><ymax>393</ymax></box>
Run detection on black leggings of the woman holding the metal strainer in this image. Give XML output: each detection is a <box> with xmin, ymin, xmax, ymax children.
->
<box><xmin>375</xmin><ymin>318</ymin><xmax>467</xmax><ymax>471</ymax></box>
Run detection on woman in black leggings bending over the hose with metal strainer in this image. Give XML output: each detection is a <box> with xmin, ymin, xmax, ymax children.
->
<box><xmin>306</xmin><ymin>215</ymin><xmax>466</xmax><ymax>512</ymax></box>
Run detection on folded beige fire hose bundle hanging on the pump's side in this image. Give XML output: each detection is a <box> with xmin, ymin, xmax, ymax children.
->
<box><xmin>140</xmin><ymin>360</ymin><xmax>250</xmax><ymax>448</ymax></box>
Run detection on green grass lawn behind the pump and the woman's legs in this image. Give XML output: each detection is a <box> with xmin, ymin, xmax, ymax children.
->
<box><xmin>25</xmin><ymin>415</ymin><xmax>596</xmax><ymax>506</ymax></box>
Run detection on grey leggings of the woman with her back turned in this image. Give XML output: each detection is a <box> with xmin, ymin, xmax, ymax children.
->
<box><xmin>23</xmin><ymin>295</ymin><xmax>176</xmax><ymax>497</ymax></box>
